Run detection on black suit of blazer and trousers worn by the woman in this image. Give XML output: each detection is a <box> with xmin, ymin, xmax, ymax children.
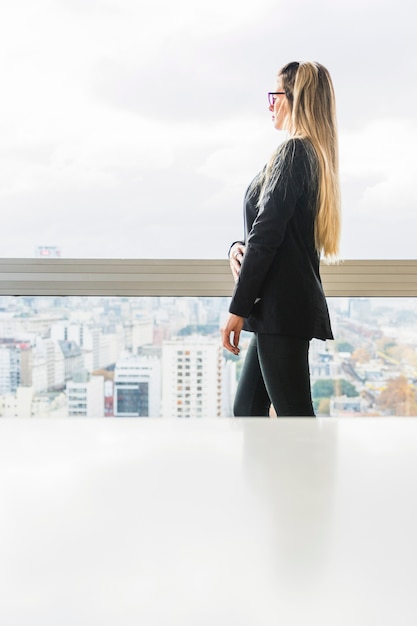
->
<box><xmin>229</xmin><ymin>139</ymin><xmax>333</xmax><ymax>416</ymax></box>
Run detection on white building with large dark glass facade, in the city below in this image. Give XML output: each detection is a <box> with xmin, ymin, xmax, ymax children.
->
<box><xmin>113</xmin><ymin>356</ymin><xmax>161</xmax><ymax>417</ymax></box>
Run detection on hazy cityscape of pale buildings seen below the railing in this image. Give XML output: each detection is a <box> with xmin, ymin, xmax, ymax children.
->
<box><xmin>0</xmin><ymin>296</ymin><xmax>417</xmax><ymax>418</ymax></box>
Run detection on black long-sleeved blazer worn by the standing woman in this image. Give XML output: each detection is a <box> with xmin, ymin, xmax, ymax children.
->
<box><xmin>229</xmin><ymin>139</ymin><xmax>333</xmax><ymax>339</ymax></box>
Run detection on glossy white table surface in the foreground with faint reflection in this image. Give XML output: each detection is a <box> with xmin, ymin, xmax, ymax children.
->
<box><xmin>0</xmin><ymin>418</ymin><xmax>417</xmax><ymax>626</ymax></box>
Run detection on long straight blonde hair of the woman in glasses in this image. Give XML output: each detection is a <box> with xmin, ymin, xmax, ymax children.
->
<box><xmin>264</xmin><ymin>62</ymin><xmax>341</xmax><ymax>262</ymax></box>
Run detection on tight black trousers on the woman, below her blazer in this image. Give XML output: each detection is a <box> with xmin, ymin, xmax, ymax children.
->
<box><xmin>233</xmin><ymin>334</ymin><xmax>314</xmax><ymax>417</ymax></box>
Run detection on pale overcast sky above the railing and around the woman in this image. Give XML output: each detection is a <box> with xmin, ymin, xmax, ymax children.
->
<box><xmin>0</xmin><ymin>0</ymin><xmax>417</xmax><ymax>259</ymax></box>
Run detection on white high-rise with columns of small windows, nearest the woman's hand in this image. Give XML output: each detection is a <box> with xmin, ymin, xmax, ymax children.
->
<box><xmin>162</xmin><ymin>335</ymin><xmax>223</xmax><ymax>417</ymax></box>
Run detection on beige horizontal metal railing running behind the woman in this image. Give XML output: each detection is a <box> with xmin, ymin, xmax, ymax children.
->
<box><xmin>0</xmin><ymin>258</ymin><xmax>417</xmax><ymax>297</ymax></box>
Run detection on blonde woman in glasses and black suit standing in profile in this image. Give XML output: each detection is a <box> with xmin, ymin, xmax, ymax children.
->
<box><xmin>222</xmin><ymin>62</ymin><xmax>340</xmax><ymax>416</ymax></box>
